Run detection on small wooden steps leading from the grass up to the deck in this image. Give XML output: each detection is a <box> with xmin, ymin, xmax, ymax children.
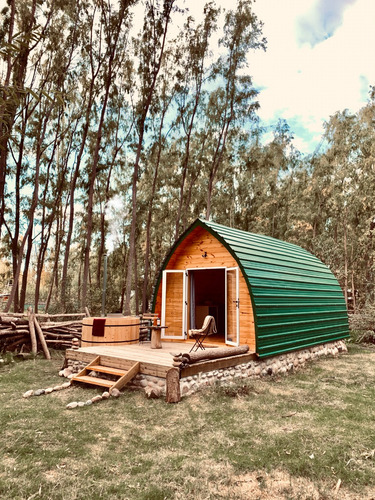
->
<box><xmin>71</xmin><ymin>356</ymin><xmax>140</xmax><ymax>393</ymax></box>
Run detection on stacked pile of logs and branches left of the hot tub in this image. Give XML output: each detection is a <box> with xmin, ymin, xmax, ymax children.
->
<box><xmin>0</xmin><ymin>309</ymin><xmax>86</xmax><ymax>359</ymax></box>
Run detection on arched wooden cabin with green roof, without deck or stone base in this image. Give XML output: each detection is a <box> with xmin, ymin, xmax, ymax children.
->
<box><xmin>153</xmin><ymin>219</ymin><xmax>349</xmax><ymax>357</ymax></box>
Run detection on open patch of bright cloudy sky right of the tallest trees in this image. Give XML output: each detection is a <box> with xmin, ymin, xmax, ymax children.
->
<box><xmin>241</xmin><ymin>0</ymin><xmax>375</xmax><ymax>154</ymax></box>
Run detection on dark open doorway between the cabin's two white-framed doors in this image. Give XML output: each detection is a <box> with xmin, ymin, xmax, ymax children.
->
<box><xmin>188</xmin><ymin>269</ymin><xmax>226</xmax><ymax>340</ymax></box>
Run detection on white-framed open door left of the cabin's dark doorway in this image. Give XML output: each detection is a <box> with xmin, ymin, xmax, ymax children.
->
<box><xmin>161</xmin><ymin>270</ymin><xmax>187</xmax><ymax>339</ymax></box>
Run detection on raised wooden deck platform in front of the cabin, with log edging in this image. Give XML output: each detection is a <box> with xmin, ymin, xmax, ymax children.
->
<box><xmin>66</xmin><ymin>341</ymin><xmax>256</xmax><ymax>378</ymax></box>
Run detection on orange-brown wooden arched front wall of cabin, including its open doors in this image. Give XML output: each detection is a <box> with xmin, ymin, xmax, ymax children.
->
<box><xmin>154</xmin><ymin>226</ymin><xmax>255</xmax><ymax>351</ymax></box>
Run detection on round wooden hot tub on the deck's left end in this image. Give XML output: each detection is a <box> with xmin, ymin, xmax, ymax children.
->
<box><xmin>81</xmin><ymin>315</ymin><xmax>140</xmax><ymax>347</ymax></box>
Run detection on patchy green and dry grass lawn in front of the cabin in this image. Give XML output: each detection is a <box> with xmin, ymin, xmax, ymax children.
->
<box><xmin>0</xmin><ymin>345</ymin><xmax>375</xmax><ymax>500</ymax></box>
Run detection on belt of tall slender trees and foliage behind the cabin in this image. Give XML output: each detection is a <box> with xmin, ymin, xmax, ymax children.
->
<box><xmin>0</xmin><ymin>0</ymin><xmax>375</xmax><ymax>313</ymax></box>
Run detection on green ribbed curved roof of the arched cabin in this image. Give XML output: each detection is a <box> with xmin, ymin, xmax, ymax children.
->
<box><xmin>153</xmin><ymin>219</ymin><xmax>349</xmax><ymax>356</ymax></box>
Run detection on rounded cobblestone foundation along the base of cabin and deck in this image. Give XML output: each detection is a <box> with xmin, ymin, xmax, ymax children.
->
<box><xmin>67</xmin><ymin>340</ymin><xmax>347</xmax><ymax>396</ymax></box>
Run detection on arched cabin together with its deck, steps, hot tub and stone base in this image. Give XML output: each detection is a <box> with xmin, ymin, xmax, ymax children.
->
<box><xmin>65</xmin><ymin>219</ymin><xmax>349</xmax><ymax>402</ymax></box>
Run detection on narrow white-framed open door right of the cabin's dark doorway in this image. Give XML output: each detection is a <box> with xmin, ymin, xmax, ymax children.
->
<box><xmin>225</xmin><ymin>267</ymin><xmax>240</xmax><ymax>346</ymax></box>
